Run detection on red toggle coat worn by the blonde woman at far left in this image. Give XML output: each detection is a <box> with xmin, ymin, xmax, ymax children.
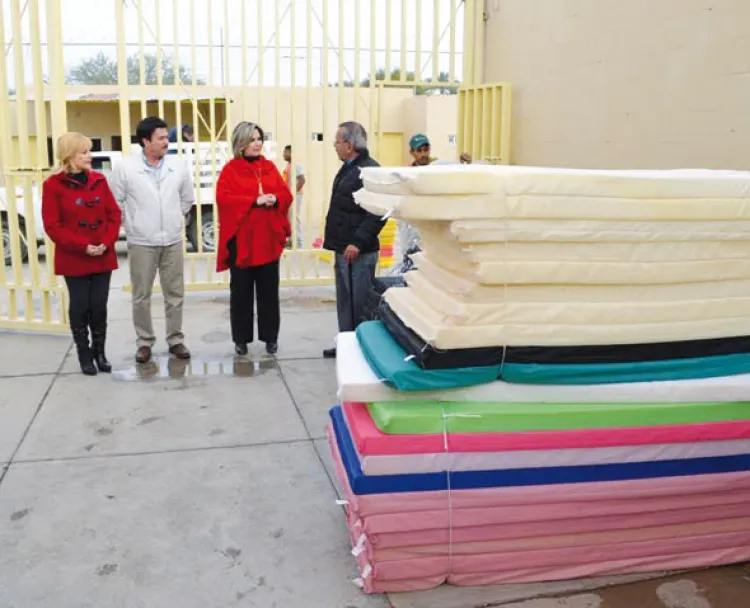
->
<box><xmin>42</xmin><ymin>171</ymin><xmax>122</xmax><ymax>277</ymax></box>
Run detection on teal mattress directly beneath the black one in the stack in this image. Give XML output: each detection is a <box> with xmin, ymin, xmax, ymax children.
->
<box><xmin>356</xmin><ymin>321</ymin><xmax>750</xmax><ymax>391</ymax></box>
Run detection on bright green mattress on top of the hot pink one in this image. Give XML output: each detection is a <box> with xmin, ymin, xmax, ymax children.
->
<box><xmin>367</xmin><ymin>401</ymin><xmax>750</xmax><ymax>435</ymax></box>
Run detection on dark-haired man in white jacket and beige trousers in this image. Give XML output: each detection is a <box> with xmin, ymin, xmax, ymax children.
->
<box><xmin>111</xmin><ymin>116</ymin><xmax>195</xmax><ymax>363</ymax></box>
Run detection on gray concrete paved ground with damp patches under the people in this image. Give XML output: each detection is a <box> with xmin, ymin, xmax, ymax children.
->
<box><xmin>0</xmin><ymin>276</ymin><xmax>750</xmax><ymax>608</ymax></box>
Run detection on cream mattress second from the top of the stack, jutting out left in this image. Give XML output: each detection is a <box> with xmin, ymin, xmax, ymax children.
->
<box><xmin>354</xmin><ymin>188</ymin><xmax>750</xmax><ymax>222</ymax></box>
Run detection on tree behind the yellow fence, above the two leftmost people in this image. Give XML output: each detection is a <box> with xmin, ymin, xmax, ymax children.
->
<box><xmin>67</xmin><ymin>51</ymin><xmax>204</xmax><ymax>85</ymax></box>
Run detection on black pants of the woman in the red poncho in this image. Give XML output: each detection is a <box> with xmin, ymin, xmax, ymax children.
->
<box><xmin>228</xmin><ymin>241</ymin><xmax>281</xmax><ymax>344</ymax></box>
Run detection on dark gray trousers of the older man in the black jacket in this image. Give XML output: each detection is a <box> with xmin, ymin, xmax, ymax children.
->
<box><xmin>334</xmin><ymin>251</ymin><xmax>380</xmax><ymax>331</ymax></box>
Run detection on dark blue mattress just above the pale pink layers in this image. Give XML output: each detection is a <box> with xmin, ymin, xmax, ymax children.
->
<box><xmin>329</xmin><ymin>406</ymin><xmax>750</xmax><ymax>495</ymax></box>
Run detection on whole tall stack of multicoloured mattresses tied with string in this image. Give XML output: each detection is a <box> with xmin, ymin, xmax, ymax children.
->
<box><xmin>329</xmin><ymin>167</ymin><xmax>750</xmax><ymax>592</ymax></box>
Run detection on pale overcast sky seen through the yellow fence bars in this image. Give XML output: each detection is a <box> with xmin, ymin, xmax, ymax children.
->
<box><xmin>0</xmin><ymin>0</ymin><xmax>463</xmax><ymax>87</ymax></box>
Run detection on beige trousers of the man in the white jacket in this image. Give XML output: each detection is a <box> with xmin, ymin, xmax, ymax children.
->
<box><xmin>128</xmin><ymin>243</ymin><xmax>185</xmax><ymax>348</ymax></box>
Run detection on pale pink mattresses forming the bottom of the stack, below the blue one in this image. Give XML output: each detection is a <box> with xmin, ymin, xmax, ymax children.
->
<box><xmin>329</xmin><ymin>429</ymin><xmax>750</xmax><ymax>593</ymax></box>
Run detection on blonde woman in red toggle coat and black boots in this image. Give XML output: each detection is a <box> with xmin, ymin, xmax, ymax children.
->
<box><xmin>42</xmin><ymin>133</ymin><xmax>122</xmax><ymax>376</ymax></box>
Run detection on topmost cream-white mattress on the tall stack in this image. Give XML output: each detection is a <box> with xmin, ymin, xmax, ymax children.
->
<box><xmin>362</xmin><ymin>165</ymin><xmax>750</xmax><ymax>197</ymax></box>
